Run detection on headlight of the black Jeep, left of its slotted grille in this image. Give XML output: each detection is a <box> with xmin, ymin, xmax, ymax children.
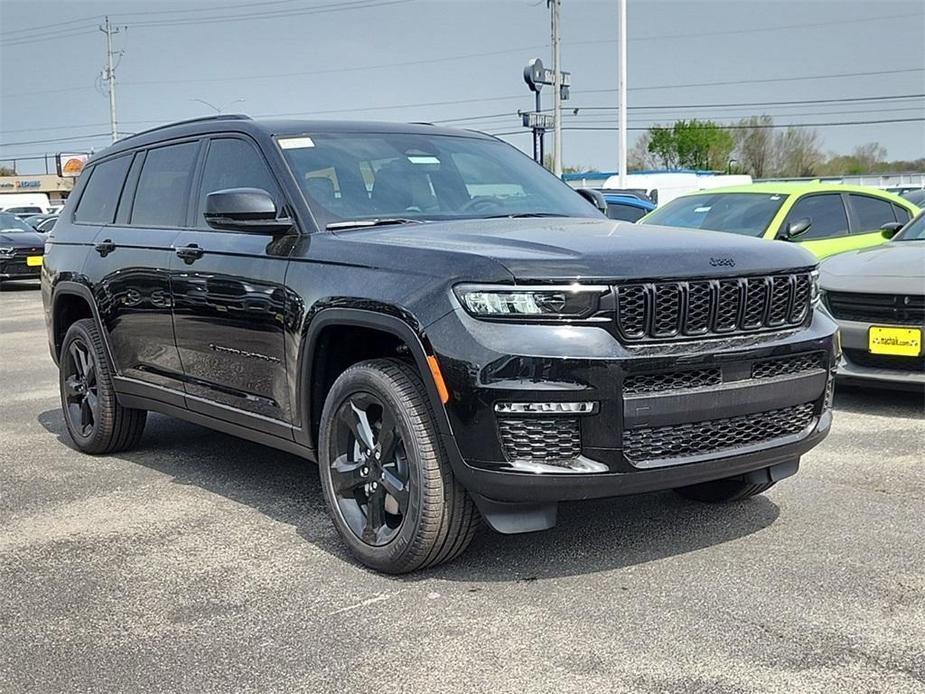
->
<box><xmin>455</xmin><ymin>284</ymin><xmax>608</xmax><ymax>320</ymax></box>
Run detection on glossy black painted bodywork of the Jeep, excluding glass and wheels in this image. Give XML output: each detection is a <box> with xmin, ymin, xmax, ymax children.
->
<box><xmin>43</xmin><ymin>118</ymin><xmax>835</xmax><ymax>513</ymax></box>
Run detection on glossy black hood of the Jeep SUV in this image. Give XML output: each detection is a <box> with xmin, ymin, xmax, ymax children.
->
<box><xmin>337</xmin><ymin>217</ymin><xmax>817</xmax><ymax>280</ymax></box>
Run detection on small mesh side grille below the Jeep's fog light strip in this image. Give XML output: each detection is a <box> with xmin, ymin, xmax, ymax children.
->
<box><xmin>498</xmin><ymin>417</ymin><xmax>581</xmax><ymax>463</ymax></box>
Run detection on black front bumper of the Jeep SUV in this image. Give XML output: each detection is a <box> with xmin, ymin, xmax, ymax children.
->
<box><xmin>428</xmin><ymin>312</ymin><xmax>835</xmax><ymax>503</ymax></box>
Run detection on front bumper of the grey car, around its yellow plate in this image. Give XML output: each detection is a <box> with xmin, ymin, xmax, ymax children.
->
<box><xmin>836</xmin><ymin>320</ymin><xmax>925</xmax><ymax>391</ymax></box>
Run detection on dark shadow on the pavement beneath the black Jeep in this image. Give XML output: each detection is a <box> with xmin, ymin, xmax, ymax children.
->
<box><xmin>38</xmin><ymin>410</ymin><xmax>779</xmax><ymax>582</ymax></box>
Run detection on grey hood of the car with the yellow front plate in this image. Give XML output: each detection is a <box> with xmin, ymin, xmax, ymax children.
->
<box><xmin>819</xmin><ymin>241</ymin><xmax>925</xmax><ymax>294</ymax></box>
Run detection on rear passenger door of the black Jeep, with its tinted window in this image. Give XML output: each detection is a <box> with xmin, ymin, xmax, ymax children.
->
<box><xmin>75</xmin><ymin>141</ymin><xmax>200</xmax><ymax>405</ymax></box>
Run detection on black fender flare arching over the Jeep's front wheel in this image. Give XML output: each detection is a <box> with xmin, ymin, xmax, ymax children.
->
<box><xmin>295</xmin><ymin>307</ymin><xmax>452</xmax><ymax>448</ymax></box>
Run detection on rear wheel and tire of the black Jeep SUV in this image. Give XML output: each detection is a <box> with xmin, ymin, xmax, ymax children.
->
<box><xmin>58</xmin><ymin>318</ymin><xmax>148</xmax><ymax>454</ymax></box>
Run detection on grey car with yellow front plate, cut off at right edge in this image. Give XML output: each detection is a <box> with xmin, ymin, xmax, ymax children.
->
<box><xmin>820</xmin><ymin>213</ymin><xmax>925</xmax><ymax>389</ymax></box>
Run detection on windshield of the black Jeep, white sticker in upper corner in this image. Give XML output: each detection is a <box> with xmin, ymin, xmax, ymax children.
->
<box><xmin>279</xmin><ymin>133</ymin><xmax>600</xmax><ymax>228</ymax></box>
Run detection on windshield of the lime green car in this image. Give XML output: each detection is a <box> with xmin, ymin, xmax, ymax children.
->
<box><xmin>643</xmin><ymin>193</ymin><xmax>787</xmax><ymax>236</ymax></box>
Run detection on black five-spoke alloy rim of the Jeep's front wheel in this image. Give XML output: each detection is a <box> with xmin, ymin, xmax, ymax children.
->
<box><xmin>331</xmin><ymin>392</ymin><xmax>411</xmax><ymax>547</ymax></box>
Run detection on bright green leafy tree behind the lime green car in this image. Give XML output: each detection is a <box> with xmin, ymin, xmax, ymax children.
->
<box><xmin>648</xmin><ymin>119</ymin><xmax>735</xmax><ymax>170</ymax></box>
